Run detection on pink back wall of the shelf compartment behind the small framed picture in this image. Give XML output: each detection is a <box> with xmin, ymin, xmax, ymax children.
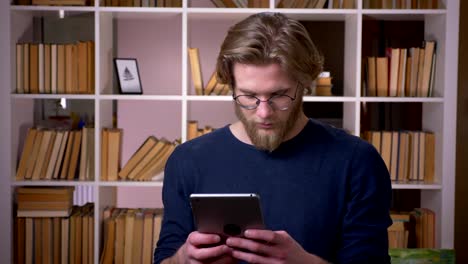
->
<box><xmin>115</xmin><ymin>14</ymin><xmax>182</xmax><ymax>95</ymax></box>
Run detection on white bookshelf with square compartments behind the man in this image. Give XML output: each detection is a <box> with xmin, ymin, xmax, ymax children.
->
<box><xmin>0</xmin><ymin>0</ymin><xmax>459</xmax><ymax>263</ymax></box>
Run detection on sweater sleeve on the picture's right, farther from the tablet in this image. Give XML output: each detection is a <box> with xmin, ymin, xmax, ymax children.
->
<box><xmin>337</xmin><ymin>141</ymin><xmax>392</xmax><ymax>264</ymax></box>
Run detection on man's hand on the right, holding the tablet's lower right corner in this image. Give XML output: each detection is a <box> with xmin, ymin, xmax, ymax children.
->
<box><xmin>226</xmin><ymin>229</ymin><xmax>327</xmax><ymax>264</ymax></box>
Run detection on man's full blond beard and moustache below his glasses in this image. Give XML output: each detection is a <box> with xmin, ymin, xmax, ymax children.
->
<box><xmin>235</xmin><ymin>96</ymin><xmax>302</xmax><ymax>152</ymax></box>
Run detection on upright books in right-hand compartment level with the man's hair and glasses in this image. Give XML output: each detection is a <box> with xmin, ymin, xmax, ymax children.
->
<box><xmin>363</xmin><ymin>41</ymin><xmax>436</xmax><ymax>97</ymax></box>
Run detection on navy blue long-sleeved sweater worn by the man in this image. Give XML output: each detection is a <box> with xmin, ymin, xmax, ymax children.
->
<box><xmin>154</xmin><ymin>120</ymin><xmax>391</xmax><ymax>263</ymax></box>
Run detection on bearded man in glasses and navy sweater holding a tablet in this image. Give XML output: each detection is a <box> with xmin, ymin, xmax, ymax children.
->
<box><xmin>155</xmin><ymin>13</ymin><xmax>391</xmax><ymax>264</ymax></box>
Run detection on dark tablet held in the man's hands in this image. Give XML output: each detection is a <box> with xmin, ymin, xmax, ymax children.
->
<box><xmin>190</xmin><ymin>193</ymin><xmax>265</xmax><ymax>238</ymax></box>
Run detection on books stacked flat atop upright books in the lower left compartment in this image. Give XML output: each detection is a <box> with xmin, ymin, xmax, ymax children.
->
<box><xmin>16</xmin><ymin>187</ymin><xmax>74</xmax><ymax>217</ymax></box>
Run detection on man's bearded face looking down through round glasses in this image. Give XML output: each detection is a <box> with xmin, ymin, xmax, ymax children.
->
<box><xmin>233</xmin><ymin>63</ymin><xmax>302</xmax><ymax>152</ymax></box>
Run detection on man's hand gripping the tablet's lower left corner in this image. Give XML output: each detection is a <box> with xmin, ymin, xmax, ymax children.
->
<box><xmin>163</xmin><ymin>231</ymin><xmax>238</xmax><ymax>264</ymax></box>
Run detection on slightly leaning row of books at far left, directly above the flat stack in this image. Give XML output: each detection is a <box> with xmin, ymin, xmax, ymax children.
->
<box><xmin>16</xmin><ymin>127</ymin><xmax>94</xmax><ymax>181</ymax></box>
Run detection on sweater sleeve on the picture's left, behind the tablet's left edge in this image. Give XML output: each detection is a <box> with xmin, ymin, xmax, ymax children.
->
<box><xmin>154</xmin><ymin>147</ymin><xmax>195</xmax><ymax>264</ymax></box>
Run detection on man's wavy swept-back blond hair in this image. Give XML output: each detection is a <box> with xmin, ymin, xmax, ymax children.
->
<box><xmin>216</xmin><ymin>12</ymin><xmax>323</xmax><ymax>93</ymax></box>
